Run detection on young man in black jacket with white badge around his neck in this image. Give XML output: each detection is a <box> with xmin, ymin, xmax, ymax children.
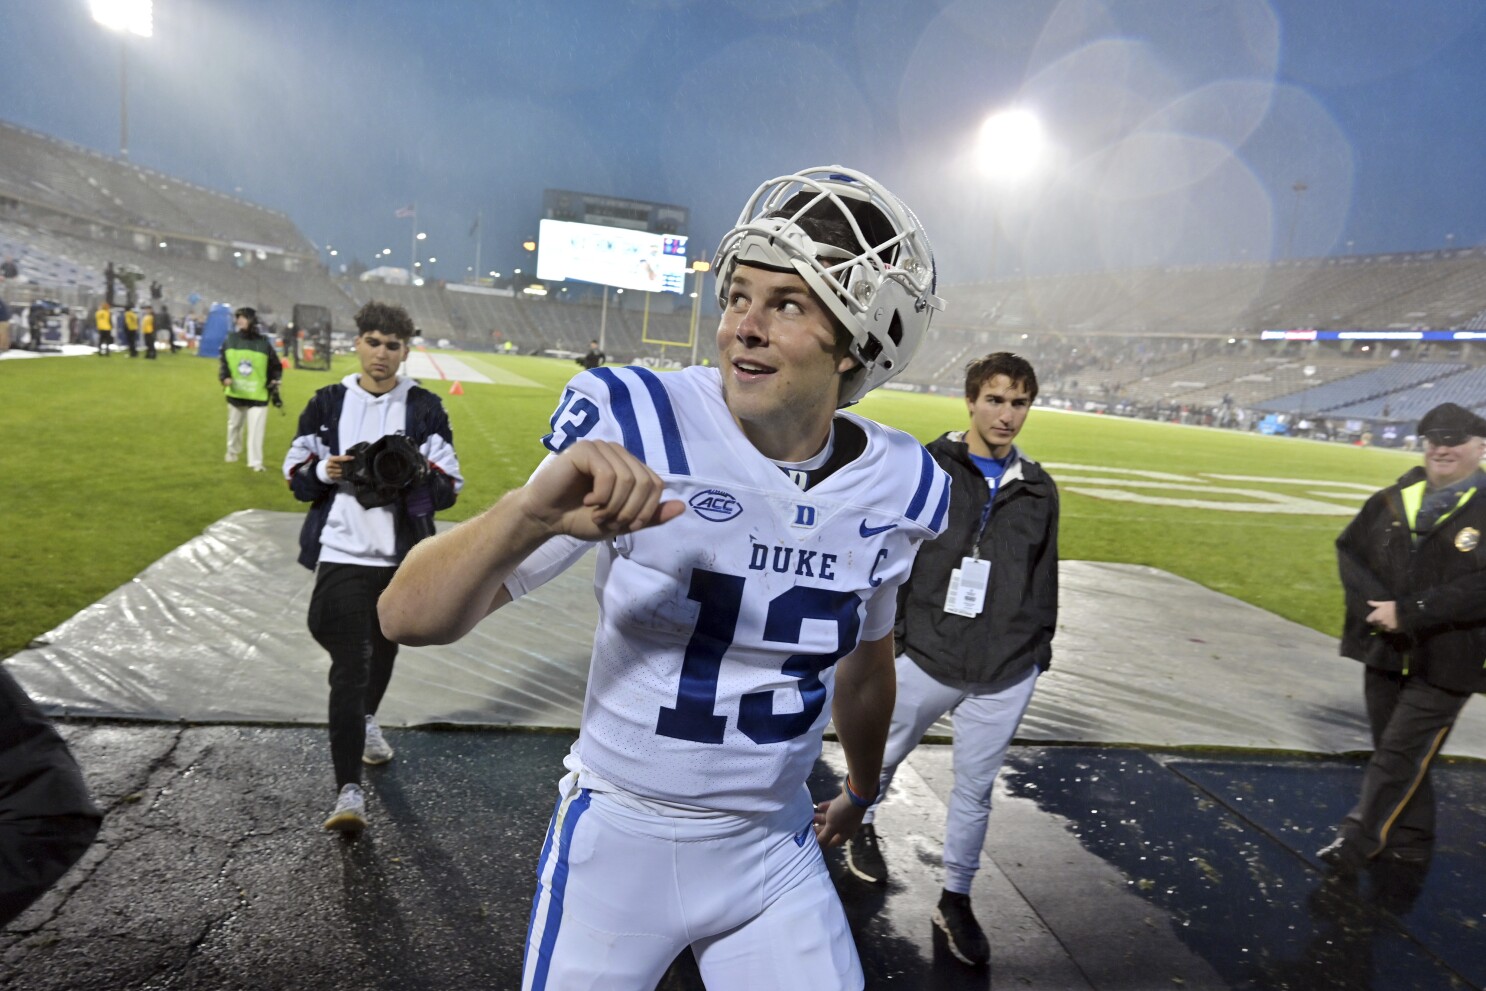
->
<box><xmin>847</xmin><ymin>352</ymin><xmax>1058</xmax><ymax>966</ymax></box>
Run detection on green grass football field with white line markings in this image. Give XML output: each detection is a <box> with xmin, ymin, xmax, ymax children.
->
<box><xmin>0</xmin><ymin>352</ymin><xmax>1418</xmax><ymax>657</ymax></box>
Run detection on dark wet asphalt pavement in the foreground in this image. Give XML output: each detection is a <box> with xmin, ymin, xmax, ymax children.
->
<box><xmin>0</xmin><ymin>721</ymin><xmax>1486</xmax><ymax>991</ymax></box>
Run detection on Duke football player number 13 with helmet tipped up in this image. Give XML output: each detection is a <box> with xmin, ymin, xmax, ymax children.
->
<box><xmin>380</xmin><ymin>166</ymin><xmax>950</xmax><ymax>991</ymax></box>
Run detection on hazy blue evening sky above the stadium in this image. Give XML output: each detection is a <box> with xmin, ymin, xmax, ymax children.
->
<box><xmin>0</xmin><ymin>0</ymin><xmax>1486</xmax><ymax>284</ymax></box>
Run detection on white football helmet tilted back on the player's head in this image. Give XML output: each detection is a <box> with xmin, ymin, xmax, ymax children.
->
<box><xmin>712</xmin><ymin>165</ymin><xmax>944</xmax><ymax>406</ymax></box>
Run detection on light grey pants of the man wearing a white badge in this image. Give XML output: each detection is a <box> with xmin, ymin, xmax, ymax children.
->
<box><xmin>862</xmin><ymin>654</ymin><xmax>1042</xmax><ymax>894</ymax></box>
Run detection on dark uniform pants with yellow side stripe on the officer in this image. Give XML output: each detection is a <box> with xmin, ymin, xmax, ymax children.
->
<box><xmin>1342</xmin><ymin>667</ymin><xmax>1470</xmax><ymax>857</ymax></box>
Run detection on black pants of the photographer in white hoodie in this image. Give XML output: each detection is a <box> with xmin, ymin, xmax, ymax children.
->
<box><xmin>309</xmin><ymin>563</ymin><xmax>397</xmax><ymax>789</ymax></box>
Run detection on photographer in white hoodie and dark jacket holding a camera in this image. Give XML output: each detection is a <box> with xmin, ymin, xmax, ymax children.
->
<box><xmin>284</xmin><ymin>303</ymin><xmax>464</xmax><ymax>832</ymax></box>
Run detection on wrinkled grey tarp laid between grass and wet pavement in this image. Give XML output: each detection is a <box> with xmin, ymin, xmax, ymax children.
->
<box><xmin>6</xmin><ymin>510</ymin><xmax>1486</xmax><ymax>758</ymax></box>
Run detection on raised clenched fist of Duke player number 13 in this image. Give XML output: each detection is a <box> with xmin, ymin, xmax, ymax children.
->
<box><xmin>522</xmin><ymin>440</ymin><xmax>685</xmax><ymax>541</ymax></box>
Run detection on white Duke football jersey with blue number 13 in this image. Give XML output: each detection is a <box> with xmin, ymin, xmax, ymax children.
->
<box><xmin>507</xmin><ymin>367</ymin><xmax>950</xmax><ymax>813</ymax></box>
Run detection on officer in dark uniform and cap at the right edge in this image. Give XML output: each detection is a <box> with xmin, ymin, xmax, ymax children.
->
<box><xmin>1317</xmin><ymin>403</ymin><xmax>1486</xmax><ymax>871</ymax></box>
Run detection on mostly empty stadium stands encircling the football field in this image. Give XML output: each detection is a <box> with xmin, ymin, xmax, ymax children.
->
<box><xmin>0</xmin><ymin>114</ymin><xmax>1486</xmax><ymax>430</ymax></box>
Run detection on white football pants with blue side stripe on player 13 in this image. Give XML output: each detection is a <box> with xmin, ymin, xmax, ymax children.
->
<box><xmin>522</xmin><ymin>773</ymin><xmax>863</xmax><ymax>991</ymax></box>
